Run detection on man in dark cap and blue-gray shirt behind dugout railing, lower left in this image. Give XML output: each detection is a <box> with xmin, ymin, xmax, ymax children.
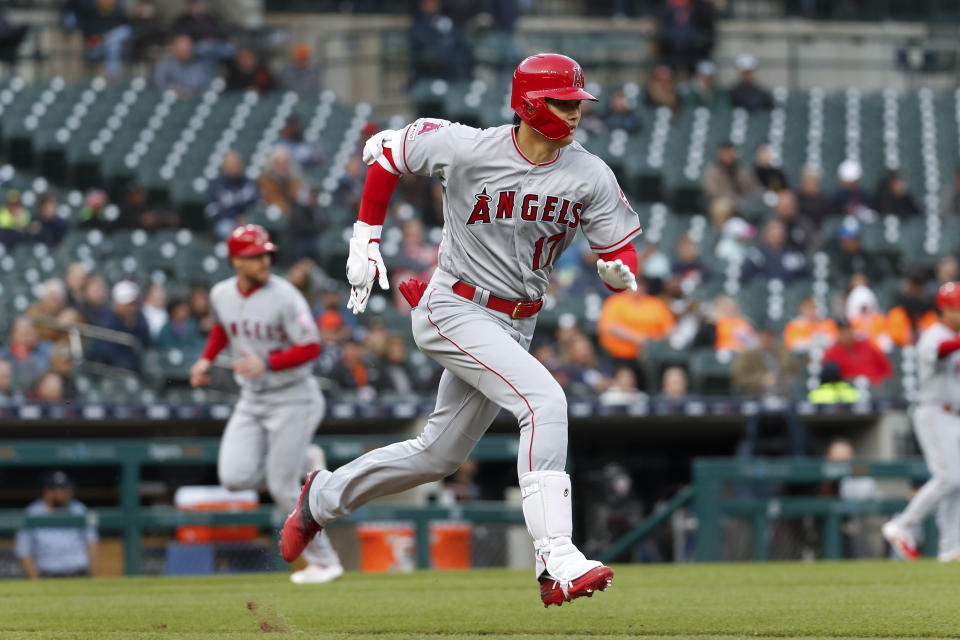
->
<box><xmin>14</xmin><ymin>471</ymin><xmax>98</xmax><ymax>580</ymax></box>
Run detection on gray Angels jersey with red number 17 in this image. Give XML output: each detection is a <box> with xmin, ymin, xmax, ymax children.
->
<box><xmin>392</xmin><ymin>119</ymin><xmax>641</xmax><ymax>300</ymax></box>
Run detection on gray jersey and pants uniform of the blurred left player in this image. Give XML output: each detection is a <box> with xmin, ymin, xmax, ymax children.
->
<box><xmin>210</xmin><ymin>275</ymin><xmax>340</xmax><ymax>566</ymax></box>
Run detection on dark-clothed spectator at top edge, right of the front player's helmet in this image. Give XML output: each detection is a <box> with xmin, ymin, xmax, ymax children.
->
<box><xmin>657</xmin><ymin>0</ymin><xmax>715</xmax><ymax>72</ymax></box>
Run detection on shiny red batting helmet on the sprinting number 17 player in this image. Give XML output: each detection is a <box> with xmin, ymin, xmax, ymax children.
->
<box><xmin>510</xmin><ymin>53</ymin><xmax>596</xmax><ymax>140</ymax></box>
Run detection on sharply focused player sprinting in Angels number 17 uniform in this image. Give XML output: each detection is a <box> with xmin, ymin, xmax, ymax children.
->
<box><xmin>281</xmin><ymin>54</ymin><xmax>641</xmax><ymax>606</ymax></box>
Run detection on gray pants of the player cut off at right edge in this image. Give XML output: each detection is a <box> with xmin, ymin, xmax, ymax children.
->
<box><xmin>897</xmin><ymin>405</ymin><xmax>960</xmax><ymax>553</ymax></box>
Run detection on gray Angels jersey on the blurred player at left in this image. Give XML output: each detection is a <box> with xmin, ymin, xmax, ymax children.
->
<box><xmin>210</xmin><ymin>275</ymin><xmax>320</xmax><ymax>395</ymax></box>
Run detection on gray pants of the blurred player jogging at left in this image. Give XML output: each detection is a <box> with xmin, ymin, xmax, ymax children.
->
<box><xmin>217</xmin><ymin>378</ymin><xmax>340</xmax><ymax>566</ymax></box>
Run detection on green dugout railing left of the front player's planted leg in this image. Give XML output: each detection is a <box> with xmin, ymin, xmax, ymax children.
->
<box><xmin>0</xmin><ymin>435</ymin><xmax>523</xmax><ymax>575</ymax></box>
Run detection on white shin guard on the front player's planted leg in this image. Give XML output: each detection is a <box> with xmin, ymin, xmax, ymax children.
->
<box><xmin>520</xmin><ymin>471</ymin><xmax>601</xmax><ymax>587</ymax></box>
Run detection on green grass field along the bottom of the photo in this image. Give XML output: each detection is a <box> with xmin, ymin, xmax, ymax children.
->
<box><xmin>0</xmin><ymin>562</ymin><xmax>960</xmax><ymax>640</ymax></box>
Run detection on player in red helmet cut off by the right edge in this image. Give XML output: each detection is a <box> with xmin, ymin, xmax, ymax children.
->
<box><xmin>883</xmin><ymin>282</ymin><xmax>960</xmax><ymax>562</ymax></box>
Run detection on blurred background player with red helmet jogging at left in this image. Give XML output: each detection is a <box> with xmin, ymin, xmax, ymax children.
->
<box><xmin>190</xmin><ymin>224</ymin><xmax>343</xmax><ymax>584</ymax></box>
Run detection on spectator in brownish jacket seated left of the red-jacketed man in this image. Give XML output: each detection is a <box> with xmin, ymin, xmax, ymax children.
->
<box><xmin>731</xmin><ymin>326</ymin><xmax>803</xmax><ymax>397</ymax></box>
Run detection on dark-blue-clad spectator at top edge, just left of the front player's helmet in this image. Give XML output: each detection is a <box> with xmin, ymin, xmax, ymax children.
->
<box><xmin>410</xmin><ymin>0</ymin><xmax>473</xmax><ymax>82</ymax></box>
